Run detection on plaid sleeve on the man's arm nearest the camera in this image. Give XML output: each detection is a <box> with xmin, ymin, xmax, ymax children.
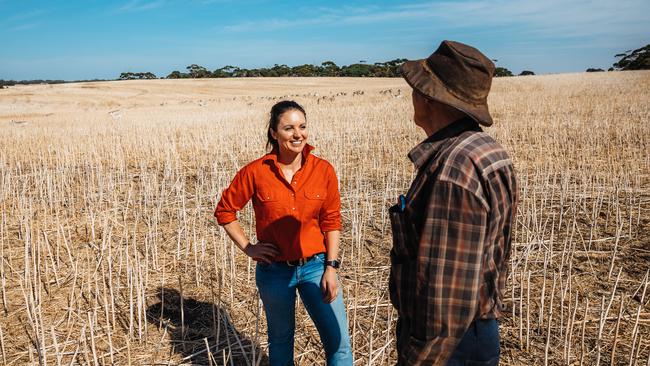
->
<box><xmin>402</xmin><ymin>181</ymin><xmax>488</xmax><ymax>365</ymax></box>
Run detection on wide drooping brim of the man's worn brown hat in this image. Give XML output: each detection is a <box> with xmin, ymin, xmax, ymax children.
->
<box><xmin>401</xmin><ymin>60</ymin><xmax>493</xmax><ymax>126</ymax></box>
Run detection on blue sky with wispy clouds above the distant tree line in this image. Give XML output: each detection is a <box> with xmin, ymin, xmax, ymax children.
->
<box><xmin>0</xmin><ymin>0</ymin><xmax>650</xmax><ymax>80</ymax></box>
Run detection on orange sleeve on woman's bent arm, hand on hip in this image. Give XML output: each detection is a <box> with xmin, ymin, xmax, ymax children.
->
<box><xmin>214</xmin><ymin>166</ymin><xmax>255</xmax><ymax>225</ymax></box>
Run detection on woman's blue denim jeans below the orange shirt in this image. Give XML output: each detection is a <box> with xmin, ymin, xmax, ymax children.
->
<box><xmin>255</xmin><ymin>254</ymin><xmax>352</xmax><ymax>366</ymax></box>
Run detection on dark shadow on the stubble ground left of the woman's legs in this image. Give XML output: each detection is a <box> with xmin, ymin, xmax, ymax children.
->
<box><xmin>147</xmin><ymin>288</ymin><xmax>269</xmax><ymax>366</ymax></box>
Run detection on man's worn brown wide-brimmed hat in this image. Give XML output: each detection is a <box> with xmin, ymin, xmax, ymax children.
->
<box><xmin>402</xmin><ymin>41</ymin><xmax>494</xmax><ymax>126</ymax></box>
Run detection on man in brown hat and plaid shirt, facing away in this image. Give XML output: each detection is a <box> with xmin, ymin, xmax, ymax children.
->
<box><xmin>390</xmin><ymin>41</ymin><xmax>518</xmax><ymax>365</ymax></box>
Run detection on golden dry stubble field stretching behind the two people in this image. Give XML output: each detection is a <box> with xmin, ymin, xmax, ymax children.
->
<box><xmin>0</xmin><ymin>72</ymin><xmax>650</xmax><ymax>365</ymax></box>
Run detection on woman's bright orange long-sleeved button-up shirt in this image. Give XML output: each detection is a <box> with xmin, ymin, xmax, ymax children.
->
<box><xmin>214</xmin><ymin>145</ymin><xmax>341</xmax><ymax>261</ymax></box>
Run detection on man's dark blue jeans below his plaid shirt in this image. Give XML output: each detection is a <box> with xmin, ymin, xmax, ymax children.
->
<box><xmin>397</xmin><ymin>318</ymin><xmax>501</xmax><ymax>366</ymax></box>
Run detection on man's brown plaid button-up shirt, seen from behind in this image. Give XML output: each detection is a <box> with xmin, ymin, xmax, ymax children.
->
<box><xmin>390</xmin><ymin>118</ymin><xmax>518</xmax><ymax>365</ymax></box>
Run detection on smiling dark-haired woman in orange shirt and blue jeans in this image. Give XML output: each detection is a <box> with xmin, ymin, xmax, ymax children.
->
<box><xmin>215</xmin><ymin>101</ymin><xmax>352</xmax><ymax>366</ymax></box>
